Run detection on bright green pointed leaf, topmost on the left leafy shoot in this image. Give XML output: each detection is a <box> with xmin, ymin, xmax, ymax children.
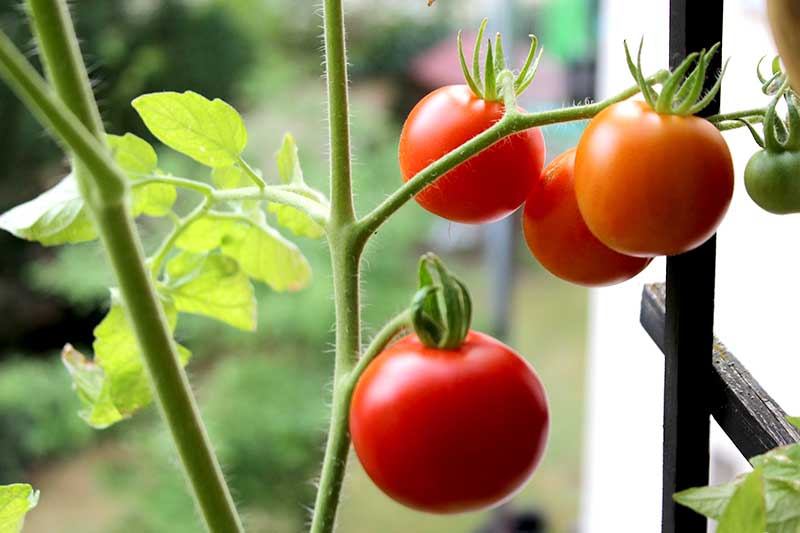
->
<box><xmin>133</xmin><ymin>91</ymin><xmax>247</xmax><ymax>168</ymax></box>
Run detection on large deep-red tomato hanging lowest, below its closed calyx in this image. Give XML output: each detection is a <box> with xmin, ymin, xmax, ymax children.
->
<box><xmin>350</xmin><ymin>331</ymin><xmax>549</xmax><ymax>513</ymax></box>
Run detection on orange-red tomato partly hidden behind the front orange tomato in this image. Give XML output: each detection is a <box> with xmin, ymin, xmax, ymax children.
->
<box><xmin>522</xmin><ymin>148</ymin><xmax>650</xmax><ymax>287</ymax></box>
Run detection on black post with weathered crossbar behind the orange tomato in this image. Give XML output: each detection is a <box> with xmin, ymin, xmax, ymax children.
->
<box><xmin>641</xmin><ymin>0</ymin><xmax>800</xmax><ymax>533</ymax></box>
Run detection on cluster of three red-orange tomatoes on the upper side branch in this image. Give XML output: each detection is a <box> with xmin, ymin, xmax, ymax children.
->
<box><xmin>400</xmin><ymin>85</ymin><xmax>733</xmax><ymax>286</ymax></box>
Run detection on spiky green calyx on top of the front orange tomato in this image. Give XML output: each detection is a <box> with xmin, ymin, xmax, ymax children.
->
<box><xmin>624</xmin><ymin>41</ymin><xmax>728</xmax><ymax>116</ymax></box>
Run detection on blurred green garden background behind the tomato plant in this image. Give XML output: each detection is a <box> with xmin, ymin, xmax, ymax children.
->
<box><xmin>0</xmin><ymin>0</ymin><xmax>595</xmax><ymax>533</ymax></box>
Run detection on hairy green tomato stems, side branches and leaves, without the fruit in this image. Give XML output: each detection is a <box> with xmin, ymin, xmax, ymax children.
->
<box><xmin>0</xmin><ymin>0</ymin><xmax>788</xmax><ymax>533</ymax></box>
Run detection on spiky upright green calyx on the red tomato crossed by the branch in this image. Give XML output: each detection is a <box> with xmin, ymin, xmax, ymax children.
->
<box><xmin>458</xmin><ymin>19</ymin><xmax>542</xmax><ymax>102</ymax></box>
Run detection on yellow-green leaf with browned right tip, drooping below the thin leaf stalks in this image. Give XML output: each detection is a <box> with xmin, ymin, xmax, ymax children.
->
<box><xmin>176</xmin><ymin>213</ymin><xmax>311</xmax><ymax>291</ymax></box>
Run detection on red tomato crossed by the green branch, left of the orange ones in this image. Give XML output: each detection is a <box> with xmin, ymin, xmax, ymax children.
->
<box><xmin>400</xmin><ymin>85</ymin><xmax>545</xmax><ymax>224</ymax></box>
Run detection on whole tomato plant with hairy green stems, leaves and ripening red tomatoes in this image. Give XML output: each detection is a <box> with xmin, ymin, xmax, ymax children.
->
<box><xmin>0</xmin><ymin>0</ymin><xmax>780</xmax><ymax>533</ymax></box>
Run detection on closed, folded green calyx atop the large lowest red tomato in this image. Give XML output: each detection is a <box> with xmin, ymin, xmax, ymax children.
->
<box><xmin>411</xmin><ymin>253</ymin><xmax>472</xmax><ymax>350</ymax></box>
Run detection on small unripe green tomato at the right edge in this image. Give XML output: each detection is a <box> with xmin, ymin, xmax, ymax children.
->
<box><xmin>744</xmin><ymin>150</ymin><xmax>800</xmax><ymax>215</ymax></box>
